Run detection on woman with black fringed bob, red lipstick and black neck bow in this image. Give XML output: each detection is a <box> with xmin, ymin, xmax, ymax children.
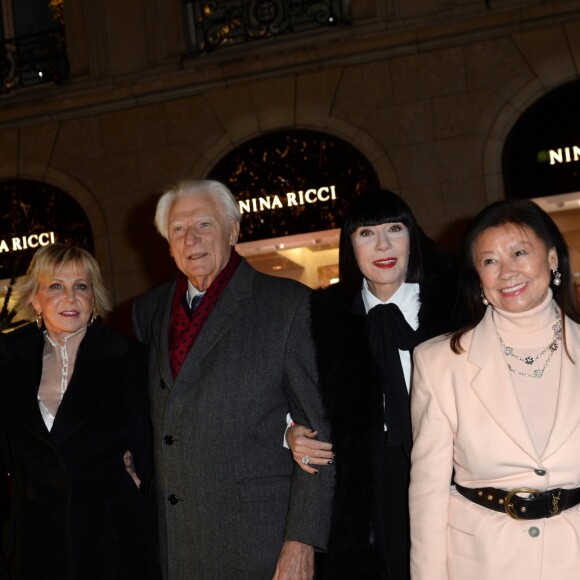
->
<box><xmin>288</xmin><ymin>189</ymin><xmax>456</xmax><ymax>580</ymax></box>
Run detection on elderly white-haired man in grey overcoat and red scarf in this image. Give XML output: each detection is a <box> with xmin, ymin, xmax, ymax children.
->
<box><xmin>133</xmin><ymin>181</ymin><xmax>334</xmax><ymax>580</ymax></box>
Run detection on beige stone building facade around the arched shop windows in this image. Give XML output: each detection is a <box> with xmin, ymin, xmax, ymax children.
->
<box><xmin>0</xmin><ymin>0</ymin><xmax>580</xmax><ymax>326</ymax></box>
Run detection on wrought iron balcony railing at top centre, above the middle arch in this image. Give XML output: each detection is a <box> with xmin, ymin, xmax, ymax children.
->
<box><xmin>183</xmin><ymin>0</ymin><xmax>350</xmax><ymax>56</ymax></box>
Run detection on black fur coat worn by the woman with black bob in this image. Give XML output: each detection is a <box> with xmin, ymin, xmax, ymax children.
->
<box><xmin>311</xmin><ymin>249</ymin><xmax>462</xmax><ymax>580</ymax></box>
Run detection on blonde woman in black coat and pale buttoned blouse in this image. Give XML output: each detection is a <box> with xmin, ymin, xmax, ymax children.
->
<box><xmin>0</xmin><ymin>244</ymin><xmax>160</xmax><ymax>580</ymax></box>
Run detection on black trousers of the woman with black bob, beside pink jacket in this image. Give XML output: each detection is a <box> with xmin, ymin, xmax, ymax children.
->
<box><xmin>371</xmin><ymin>445</ymin><xmax>411</xmax><ymax>580</ymax></box>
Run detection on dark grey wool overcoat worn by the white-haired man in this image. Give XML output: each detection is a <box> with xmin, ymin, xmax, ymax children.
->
<box><xmin>133</xmin><ymin>260</ymin><xmax>334</xmax><ymax>580</ymax></box>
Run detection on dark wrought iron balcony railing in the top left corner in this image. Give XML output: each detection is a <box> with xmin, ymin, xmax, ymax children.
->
<box><xmin>0</xmin><ymin>27</ymin><xmax>69</xmax><ymax>94</ymax></box>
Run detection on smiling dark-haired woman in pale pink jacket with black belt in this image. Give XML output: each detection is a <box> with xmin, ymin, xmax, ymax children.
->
<box><xmin>410</xmin><ymin>201</ymin><xmax>580</xmax><ymax>580</ymax></box>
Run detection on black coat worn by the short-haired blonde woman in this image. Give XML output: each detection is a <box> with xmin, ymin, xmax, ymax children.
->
<box><xmin>0</xmin><ymin>323</ymin><xmax>158</xmax><ymax>580</ymax></box>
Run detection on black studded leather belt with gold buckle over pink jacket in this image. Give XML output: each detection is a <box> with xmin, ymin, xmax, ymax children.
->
<box><xmin>455</xmin><ymin>484</ymin><xmax>580</xmax><ymax>520</ymax></box>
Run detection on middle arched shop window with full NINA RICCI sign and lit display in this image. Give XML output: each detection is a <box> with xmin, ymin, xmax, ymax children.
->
<box><xmin>209</xmin><ymin>130</ymin><xmax>378</xmax><ymax>287</ymax></box>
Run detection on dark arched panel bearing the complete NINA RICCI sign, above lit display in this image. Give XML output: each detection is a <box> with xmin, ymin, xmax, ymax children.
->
<box><xmin>209</xmin><ymin>130</ymin><xmax>378</xmax><ymax>242</ymax></box>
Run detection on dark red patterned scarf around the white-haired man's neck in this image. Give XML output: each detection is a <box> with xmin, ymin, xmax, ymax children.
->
<box><xmin>169</xmin><ymin>249</ymin><xmax>241</xmax><ymax>378</ymax></box>
